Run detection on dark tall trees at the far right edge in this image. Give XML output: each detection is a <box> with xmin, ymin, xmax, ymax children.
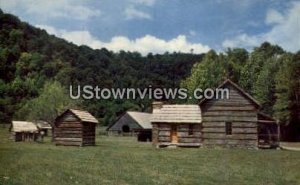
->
<box><xmin>273</xmin><ymin>52</ymin><xmax>300</xmax><ymax>140</ymax></box>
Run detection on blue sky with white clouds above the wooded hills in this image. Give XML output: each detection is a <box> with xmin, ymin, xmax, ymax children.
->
<box><xmin>0</xmin><ymin>0</ymin><xmax>300</xmax><ymax>55</ymax></box>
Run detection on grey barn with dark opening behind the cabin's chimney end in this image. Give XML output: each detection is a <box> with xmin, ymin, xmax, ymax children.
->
<box><xmin>107</xmin><ymin>111</ymin><xmax>152</xmax><ymax>141</ymax></box>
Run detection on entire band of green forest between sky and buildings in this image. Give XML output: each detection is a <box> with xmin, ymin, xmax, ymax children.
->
<box><xmin>0</xmin><ymin>10</ymin><xmax>300</xmax><ymax>139</ymax></box>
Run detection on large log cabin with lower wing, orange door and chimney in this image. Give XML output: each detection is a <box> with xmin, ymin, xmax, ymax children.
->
<box><xmin>151</xmin><ymin>79</ymin><xmax>279</xmax><ymax>148</ymax></box>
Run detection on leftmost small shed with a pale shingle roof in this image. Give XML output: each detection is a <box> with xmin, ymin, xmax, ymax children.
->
<box><xmin>10</xmin><ymin>121</ymin><xmax>39</xmax><ymax>142</ymax></box>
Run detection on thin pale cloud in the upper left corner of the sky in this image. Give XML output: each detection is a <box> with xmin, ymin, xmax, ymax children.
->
<box><xmin>0</xmin><ymin>0</ymin><xmax>101</xmax><ymax>20</ymax></box>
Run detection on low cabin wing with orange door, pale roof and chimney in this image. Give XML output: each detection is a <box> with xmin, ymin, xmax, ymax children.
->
<box><xmin>151</xmin><ymin>102</ymin><xmax>201</xmax><ymax>147</ymax></box>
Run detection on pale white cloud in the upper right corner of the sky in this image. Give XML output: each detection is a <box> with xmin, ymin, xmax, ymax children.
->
<box><xmin>222</xmin><ymin>2</ymin><xmax>300</xmax><ymax>52</ymax></box>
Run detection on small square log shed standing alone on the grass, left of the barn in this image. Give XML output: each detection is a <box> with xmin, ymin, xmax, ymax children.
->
<box><xmin>54</xmin><ymin>109</ymin><xmax>98</xmax><ymax>146</ymax></box>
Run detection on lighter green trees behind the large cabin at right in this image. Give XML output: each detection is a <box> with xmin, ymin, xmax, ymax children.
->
<box><xmin>181</xmin><ymin>42</ymin><xmax>300</xmax><ymax>140</ymax></box>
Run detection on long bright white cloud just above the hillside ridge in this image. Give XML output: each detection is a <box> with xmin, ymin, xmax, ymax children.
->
<box><xmin>37</xmin><ymin>25</ymin><xmax>210</xmax><ymax>55</ymax></box>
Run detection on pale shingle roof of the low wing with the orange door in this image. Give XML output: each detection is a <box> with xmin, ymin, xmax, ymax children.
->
<box><xmin>150</xmin><ymin>104</ymin><xmax>202</xmax><ymax>123</ymax></box>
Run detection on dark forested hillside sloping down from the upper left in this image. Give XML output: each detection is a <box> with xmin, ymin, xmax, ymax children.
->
<box><xmin>0</xmin><ymin>11</ymin><xmax>202</xmax><ymax>125</ymax></box>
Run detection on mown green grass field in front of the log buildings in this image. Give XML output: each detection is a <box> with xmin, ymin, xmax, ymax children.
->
<box><xmin>0</xmin><ymin>128</ymin><xmax>300</xmax><ymax>185</ymax></box>
